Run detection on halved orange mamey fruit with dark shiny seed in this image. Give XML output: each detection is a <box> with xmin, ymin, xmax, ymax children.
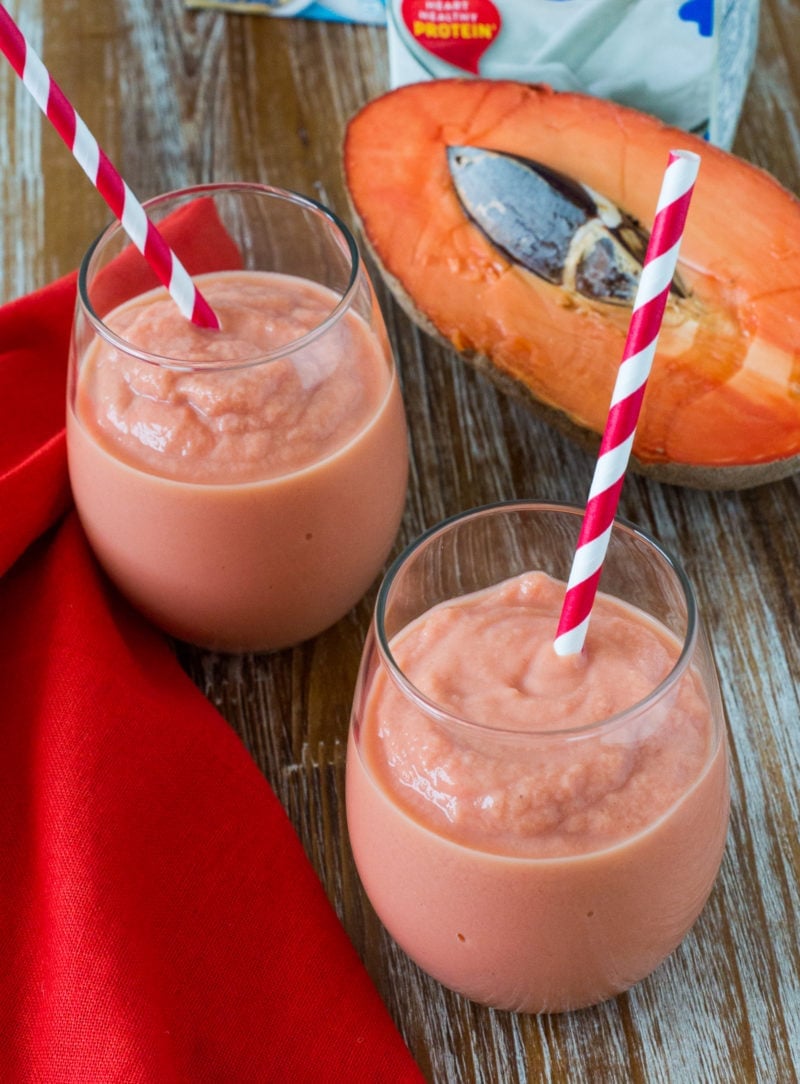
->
<box><xmin>344</xmin><ymin>79</ymin><xmax>800</xmax><ymax>489</ymax></box>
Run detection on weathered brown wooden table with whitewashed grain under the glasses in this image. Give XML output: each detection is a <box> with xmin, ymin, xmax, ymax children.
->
<box><xmin>0</xmin><ymin>0</ymin><xmax>800</xmax><ymax>1084</ymax></box>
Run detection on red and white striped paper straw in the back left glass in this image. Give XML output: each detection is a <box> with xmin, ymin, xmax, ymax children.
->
<box><xmin>0</xmin><ymin>4</ymin><xmax>219</xmax><ymax>328</ymax></box>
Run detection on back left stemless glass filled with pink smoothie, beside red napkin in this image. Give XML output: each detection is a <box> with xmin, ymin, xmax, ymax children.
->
<box><xmin>67</xmin><ymin>183</ymin><xmax>408</xmax><ymax>651</ymax></box>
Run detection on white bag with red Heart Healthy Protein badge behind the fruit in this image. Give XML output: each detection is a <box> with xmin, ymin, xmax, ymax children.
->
<box><xmin>388</xmin><ymin>0</ymin><xmax>759</xmax><ymax>149</ymax></box>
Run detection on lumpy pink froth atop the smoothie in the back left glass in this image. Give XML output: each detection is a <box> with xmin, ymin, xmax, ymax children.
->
<box><xmin>77</xmin><ymin>272</ymin><xmax>389</xmax><ymax>483</ymax></box>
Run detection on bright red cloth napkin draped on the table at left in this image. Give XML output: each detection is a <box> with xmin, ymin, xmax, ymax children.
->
<box><xmin>0</xmin><ymin>222</ymin><xmax>422</xmax><ymax>1084</ymax></box>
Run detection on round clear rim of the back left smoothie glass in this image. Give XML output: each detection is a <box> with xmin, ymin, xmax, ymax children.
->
<box><xmin>77</xmin><ymin>181</ymin><xmax>362</xmax><ymax>372</ymax></box>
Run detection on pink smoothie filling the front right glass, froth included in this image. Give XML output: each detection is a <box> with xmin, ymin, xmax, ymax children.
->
<box><xmin>347</xmin><ymin>572</ymin><xmax>728</xmax><ymax>1012</ymax></box>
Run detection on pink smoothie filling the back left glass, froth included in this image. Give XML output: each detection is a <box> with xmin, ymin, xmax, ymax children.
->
<box><xmin>67</xmin><ymin>271</ymin><xmax>408</xmax><ymax>650</ymax></box>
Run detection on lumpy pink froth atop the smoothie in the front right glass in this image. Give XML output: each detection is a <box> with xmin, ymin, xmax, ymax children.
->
<box><xmin>364</xmin><ymin>573</ymin><xmax>713</xmax><ymax>856</ymax></box>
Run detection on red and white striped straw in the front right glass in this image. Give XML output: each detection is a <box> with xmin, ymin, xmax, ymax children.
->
<box><xmin>553</xmin><ymin>151</ymin><xmax>700</xmax><ymax>655</ymax></box>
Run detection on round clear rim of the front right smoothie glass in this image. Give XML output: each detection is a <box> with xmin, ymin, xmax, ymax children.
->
<box><xmin>373</xmin><ymin>500</ymin><xmax>699</xmax><ymax>741</ymax></box>
